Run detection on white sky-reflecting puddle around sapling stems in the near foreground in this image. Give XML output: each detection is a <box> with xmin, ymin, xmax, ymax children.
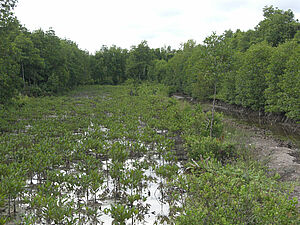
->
<box><xmin>20</xmin><ymin>157</ymin><xmax>180</xmax><ymax>224</ymax></box>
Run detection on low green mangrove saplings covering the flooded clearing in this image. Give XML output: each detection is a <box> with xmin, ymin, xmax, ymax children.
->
<box><xmin>0</xmin><ymin>86</ymin><xmax>296</xmax><ymax>224</ymax></box>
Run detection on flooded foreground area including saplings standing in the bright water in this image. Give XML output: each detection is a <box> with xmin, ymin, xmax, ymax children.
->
<box><xmin>19</xmin><ymin>122</ymin><xmax>182</xmax><ymax>225</ymax></box>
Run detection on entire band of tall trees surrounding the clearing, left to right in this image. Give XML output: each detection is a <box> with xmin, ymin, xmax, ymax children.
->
<box><xmin>0</xmin><ymin>0</ymin><xmax>300</xmax><ymax>121</ymax></box>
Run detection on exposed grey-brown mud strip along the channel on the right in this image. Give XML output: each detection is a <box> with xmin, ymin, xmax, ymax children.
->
<box><xmin>173</xmin><ymin>94</ymin><xmax>300</xmax><ymax>207</ymax></box>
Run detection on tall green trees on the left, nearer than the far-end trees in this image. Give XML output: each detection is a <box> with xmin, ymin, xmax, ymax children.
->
<box><xmin>0</xmin><ymin>0</ymin><xmax>91</xmax><ymax>104</ymax></box>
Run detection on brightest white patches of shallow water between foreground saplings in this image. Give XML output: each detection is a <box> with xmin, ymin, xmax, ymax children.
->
<box><xmin>20</xmin><ymin>157</ymin><xmax>180</xmax><ymax>225</ymax></box>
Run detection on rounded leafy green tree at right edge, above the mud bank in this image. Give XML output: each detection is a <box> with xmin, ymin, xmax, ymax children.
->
<box><xmin>265</xmin><ymin>41</ymin><xmax>300</xmax><ymax>120</ymax></box>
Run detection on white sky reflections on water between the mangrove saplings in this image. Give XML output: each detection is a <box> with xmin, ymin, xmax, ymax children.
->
<box><xmin>23</xmin><ymin>123</ymin><xmax>180</xmax><ymax>224</ymax></box>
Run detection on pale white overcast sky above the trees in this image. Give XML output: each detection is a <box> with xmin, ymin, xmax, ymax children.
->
<box><xmin>15</xmin><ymin>0</ymin><xmax>300</xmax><ymax>53</ymax></box>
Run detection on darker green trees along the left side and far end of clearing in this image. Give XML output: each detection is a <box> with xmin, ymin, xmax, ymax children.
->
<box><xmin>0</xmin><ymin>0</ymin><xmax>175</xmax><ymax>101</ymax></box>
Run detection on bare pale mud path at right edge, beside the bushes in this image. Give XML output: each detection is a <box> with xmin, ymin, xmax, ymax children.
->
<box><xmin>224</xmin><ymin>118</ymin><xmax>300</xmax><ymax>209</ymax></box>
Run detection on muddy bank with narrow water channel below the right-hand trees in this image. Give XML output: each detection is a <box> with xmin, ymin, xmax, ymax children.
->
<box><xmin>173</xmin><ymin>94</ymin><xmax>300</xmax><ymax>208</ymax></box>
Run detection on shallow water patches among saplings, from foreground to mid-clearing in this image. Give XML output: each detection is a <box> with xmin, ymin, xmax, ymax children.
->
<box><xmin>19</xmin><ymin>123</ymin><xmax>182</xmax><ymax>225</ymax></box>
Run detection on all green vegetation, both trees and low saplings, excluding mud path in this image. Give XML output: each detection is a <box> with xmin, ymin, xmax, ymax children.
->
<box><xmin>0</xmin><ymin>0</ymin><xmax>300</xmax><ymax>224</ymax></box>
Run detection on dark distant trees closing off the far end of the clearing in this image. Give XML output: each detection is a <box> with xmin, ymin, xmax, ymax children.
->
<box><xmin>91</xmin><ymin>41</ymin><xmax>176</xmax><ymax>84</ymax></box>
